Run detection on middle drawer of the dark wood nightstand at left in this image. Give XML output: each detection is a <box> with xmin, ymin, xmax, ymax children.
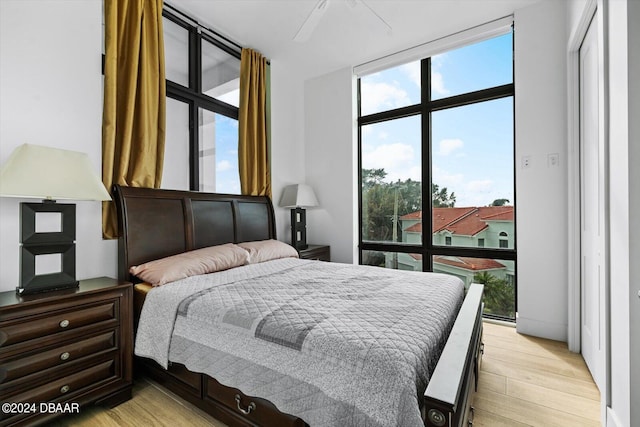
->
<box><xmin>0</xmin><ymin>330</ymin><xmax>118</xmax><ymax>384</ymax></box>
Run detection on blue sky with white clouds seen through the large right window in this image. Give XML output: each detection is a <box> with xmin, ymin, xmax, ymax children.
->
<box><xmin>361</xmin><ymin>33</ymin><xmax>514</xmax><ymax>207</ymax></box>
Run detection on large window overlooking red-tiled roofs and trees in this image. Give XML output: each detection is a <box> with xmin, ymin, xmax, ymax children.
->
<box><xmin>358</xmin><ymin>28</ymin><xmax>516</xmax><ymax>319</ymax></box>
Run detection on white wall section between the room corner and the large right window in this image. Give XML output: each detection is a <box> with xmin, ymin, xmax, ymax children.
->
<box><xmin>304</xmin><ymin>67</ymin><xmax>358</xmax><ymax>263</ymax></box>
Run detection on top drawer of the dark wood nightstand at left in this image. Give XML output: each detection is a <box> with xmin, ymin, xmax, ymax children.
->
<box><xmin>0</xmin><ymin>300</ymin><xmax>118</xmax><ymax>347</ymax></box>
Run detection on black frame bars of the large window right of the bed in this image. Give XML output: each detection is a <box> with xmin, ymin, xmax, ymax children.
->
<box><xmin>356</xmin><ymin>26</ymin><xmax>518</xmax><ymax>320</ymax></box>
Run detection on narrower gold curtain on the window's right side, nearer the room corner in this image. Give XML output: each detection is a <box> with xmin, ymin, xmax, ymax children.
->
<box><xmin>238</xmin><ymin>49</ymin><xmax>271</xmax><ymax>197</ymax></box>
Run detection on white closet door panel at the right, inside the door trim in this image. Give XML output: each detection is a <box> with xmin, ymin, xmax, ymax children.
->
<box><xmin>579</xmin><ymin>14</ymin><xmax>605</xmax><ymax>390</ymax></box>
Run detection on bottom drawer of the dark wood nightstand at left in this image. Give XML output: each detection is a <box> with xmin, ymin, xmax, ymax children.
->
<box><xmin>0</xmin><ymin>358</ymin><xmax>116</xmax><ymax>421</ymax></box>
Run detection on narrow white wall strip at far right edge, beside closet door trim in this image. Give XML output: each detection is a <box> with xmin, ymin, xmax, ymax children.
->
<box><xmin>603</xmin><ymin>0</ymin><xmax>640</xmax><ymax>426</ymax></box>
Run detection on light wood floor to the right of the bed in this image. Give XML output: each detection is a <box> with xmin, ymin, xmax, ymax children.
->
<box><xmin>473</xmin><ymin>322</ymin><xmax>600</xmax><ymax>427</ymax></box>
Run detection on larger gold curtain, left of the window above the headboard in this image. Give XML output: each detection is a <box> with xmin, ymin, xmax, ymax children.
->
<box><xmin>102</xmin><ymin>0</ymin><xmax>166</xmax><ymax>239</ymax></box>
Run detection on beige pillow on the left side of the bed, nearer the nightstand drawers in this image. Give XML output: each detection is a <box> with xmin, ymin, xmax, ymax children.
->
<box><xmin>129</xmin><ymin>243</ymin><xmax>249</xmax><ymax>286</ymax></box>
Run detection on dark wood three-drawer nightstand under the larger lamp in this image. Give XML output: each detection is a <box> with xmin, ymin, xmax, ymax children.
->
<box><xmin>0</xmin><ymin>277</ymin><xmax>133</xmax><ymax>426</ymax></box>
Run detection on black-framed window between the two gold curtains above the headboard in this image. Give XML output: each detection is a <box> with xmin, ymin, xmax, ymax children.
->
<box><xmin>162</xmin><ymin>4</ymin><xmax>240</xmax><ymax>194</ymax></box>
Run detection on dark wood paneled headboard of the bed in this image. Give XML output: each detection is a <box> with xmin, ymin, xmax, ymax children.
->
<box><xmin>113</xmin><ymin>185</ymin><xmax>276</xmax><ymax>280</ymax></box>
